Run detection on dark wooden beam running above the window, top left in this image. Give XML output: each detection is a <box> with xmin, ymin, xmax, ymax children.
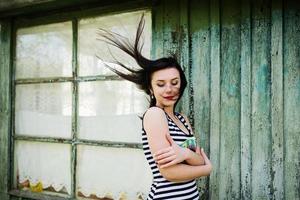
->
<box><xmin>0</xmin><ymin>0</ymin><xmax>152</xmax><ymax>19</ymax></box>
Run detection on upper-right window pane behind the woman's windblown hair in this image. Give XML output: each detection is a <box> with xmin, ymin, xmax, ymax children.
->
<box><xmin>78</xmin><ymin>11</ymin><xmax>151</xmax><ymax>76</ymax></box>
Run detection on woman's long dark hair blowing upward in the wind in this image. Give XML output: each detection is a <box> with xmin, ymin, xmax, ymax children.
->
<box><xmin>97</xmin><ymin>14</ymin><xmax>187</xmax><ymax>108</ymax></box>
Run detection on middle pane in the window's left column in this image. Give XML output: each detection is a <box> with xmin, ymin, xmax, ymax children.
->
<box><xmin>15</xmin><ymin>83</ymin><xmax>72</xmax><ymax>138</ymax></box>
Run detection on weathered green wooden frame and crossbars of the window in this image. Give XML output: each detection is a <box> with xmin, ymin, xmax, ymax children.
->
<box><xmin>8</xmin><ymin>2</ymin><xmax>153</xmax><ymax>200</ymax></box>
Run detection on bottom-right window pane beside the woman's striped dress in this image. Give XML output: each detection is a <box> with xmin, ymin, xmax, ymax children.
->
<box><xmin>76</xmin><ymin>145</ymin><xmax>152</xmax><ymax>200</ymax></box>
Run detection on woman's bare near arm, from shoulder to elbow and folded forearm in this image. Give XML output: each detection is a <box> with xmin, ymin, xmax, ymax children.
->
<box><xmin>143</xmin><ymin>107</ymin><xmax>212</xmax><ymax>182</ymax></box>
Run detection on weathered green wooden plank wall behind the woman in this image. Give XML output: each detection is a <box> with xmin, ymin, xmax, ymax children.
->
<box><xmin>0</xmin><ymin>0</ymin><xmax>300</xmax><ymax>200</ymax></box>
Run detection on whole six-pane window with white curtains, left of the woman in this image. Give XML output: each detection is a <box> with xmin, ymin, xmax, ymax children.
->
<box><xmin>13</xmin><ymin>11</ymin><xmax>151</xmax><ymax>199</ymax></box>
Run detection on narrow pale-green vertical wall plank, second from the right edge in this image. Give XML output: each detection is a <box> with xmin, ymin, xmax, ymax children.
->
<box><xmin>271</xmin><ymin>0</ymin><xmax>284</xmax><ymax>199</ymax></box>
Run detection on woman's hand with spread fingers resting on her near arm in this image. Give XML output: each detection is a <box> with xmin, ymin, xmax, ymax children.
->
<box><xmin>154</xmin><ymin>134</ymin><xmax>188</xmax><ymax>168</ymax></box>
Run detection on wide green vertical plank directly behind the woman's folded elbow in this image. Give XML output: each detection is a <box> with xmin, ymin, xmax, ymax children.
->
<box><xmin>190</xmin><ymin>1</ymin><xmax>210</xmax><ymax>198</ymax></box>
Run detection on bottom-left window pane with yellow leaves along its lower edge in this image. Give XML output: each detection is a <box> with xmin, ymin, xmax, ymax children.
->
<box><xmin>14</xmin><ymin>141</ymin><xmax>71</xmax><ymax>194</ymax></box>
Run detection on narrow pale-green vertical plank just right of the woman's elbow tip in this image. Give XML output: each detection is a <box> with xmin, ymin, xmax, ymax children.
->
<box><xmin>209</xmin><ymin>0</ymin><xmax>221</xmax><ymax>199</ymax></box>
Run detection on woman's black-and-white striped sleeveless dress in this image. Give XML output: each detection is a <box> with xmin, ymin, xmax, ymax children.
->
<box><xmin>142</xmin><ymin>108</ymin><xmax>199</xmax><ymax>200</ymax></box>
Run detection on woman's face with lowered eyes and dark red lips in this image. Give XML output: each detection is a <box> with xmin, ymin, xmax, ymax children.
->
<box><xmin>151</xmin><ymin>67</ymin><xmax>181</xmax><ymax>107</ymax></box>
